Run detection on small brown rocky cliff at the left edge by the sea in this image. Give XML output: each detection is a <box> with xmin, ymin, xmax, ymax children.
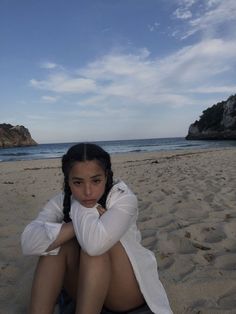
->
<box><xmin>0</xmin><ymin>123</ymin><xmax>37</xmax><ymax>148</ymax></box>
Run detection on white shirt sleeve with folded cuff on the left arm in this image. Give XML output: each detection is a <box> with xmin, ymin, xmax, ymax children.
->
<box><xmin>21</xmin><ymin>193</ymin><xmax>63</xmax><ymax>255</ymax></box>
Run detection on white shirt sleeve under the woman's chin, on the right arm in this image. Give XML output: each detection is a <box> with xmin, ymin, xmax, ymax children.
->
<box><xmin>71</xmin><ymin>183</ymin><xmax>137</xmax><ymax>256</ymax></box>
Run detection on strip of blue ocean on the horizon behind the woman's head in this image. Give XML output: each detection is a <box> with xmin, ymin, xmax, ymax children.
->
<box><xmin>0</xmin><ymin>137</ymin><xmax>236</xmax><ymax>162</ymax></box>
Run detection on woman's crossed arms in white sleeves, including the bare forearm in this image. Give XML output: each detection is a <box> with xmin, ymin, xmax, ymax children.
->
<box><xmin>22</xmin><ymin>193</ymin><xmax>137</xmax><ymax>255</ymax></box>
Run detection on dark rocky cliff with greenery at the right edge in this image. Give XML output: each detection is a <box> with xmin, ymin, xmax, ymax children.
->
<box><xmin>186</xmin><ymin>95</ymin><xmax>236</xmax><ymax>140</ymax></box>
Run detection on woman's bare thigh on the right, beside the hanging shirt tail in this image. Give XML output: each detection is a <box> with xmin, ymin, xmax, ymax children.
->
<box><xmin>105</xmin><ymin>242</ymin><xmax>144</xmax><ymax>310</ymax></box>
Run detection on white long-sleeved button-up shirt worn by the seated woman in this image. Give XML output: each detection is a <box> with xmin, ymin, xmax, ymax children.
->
<box><xmin>21</xmin><ymin>181</ymin><xmax>172</xmax><ymax>314</ymax></box>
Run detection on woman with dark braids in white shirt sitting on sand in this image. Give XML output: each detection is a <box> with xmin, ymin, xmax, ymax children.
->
<box><xmin>22</xmin><ymin>143</ymin><xmax>172</xmax><ymax>314</ymax></box>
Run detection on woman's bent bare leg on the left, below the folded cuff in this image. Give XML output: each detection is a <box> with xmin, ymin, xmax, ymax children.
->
<box><xmin>30</xmin><ymin>240</ymin><xmax>79</xmax><ymax>314</ymax></box>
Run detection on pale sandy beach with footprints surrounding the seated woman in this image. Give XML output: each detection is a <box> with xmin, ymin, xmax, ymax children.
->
<box><xmin>0</xmin><ymin>148</ymin><xmax>236</xmax><ymax>314</ymax></box>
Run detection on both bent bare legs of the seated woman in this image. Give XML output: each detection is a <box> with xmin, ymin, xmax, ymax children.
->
<box><xmin>30</xmin><ymin>240</ymin><xmax>144</xmax><ymax>314</ymax></box>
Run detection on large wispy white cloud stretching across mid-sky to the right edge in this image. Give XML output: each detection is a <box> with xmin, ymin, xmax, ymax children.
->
<box><xmin>31</xmin><ymin>39</ymin><xmax>236</xmax><ymax>111</ymax></box>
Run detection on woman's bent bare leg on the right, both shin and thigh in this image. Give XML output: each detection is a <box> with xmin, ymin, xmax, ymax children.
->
<box><xmin>76</xmin><ymin>242</ymin><xmax>144</xmax><ymax>314</ymax></box>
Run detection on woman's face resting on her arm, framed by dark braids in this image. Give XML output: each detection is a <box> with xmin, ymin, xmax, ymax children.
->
<box><xmin>69</xmin><ymin>160</ymin><xmax>107</xmax><ymax>207</ymax></box>
